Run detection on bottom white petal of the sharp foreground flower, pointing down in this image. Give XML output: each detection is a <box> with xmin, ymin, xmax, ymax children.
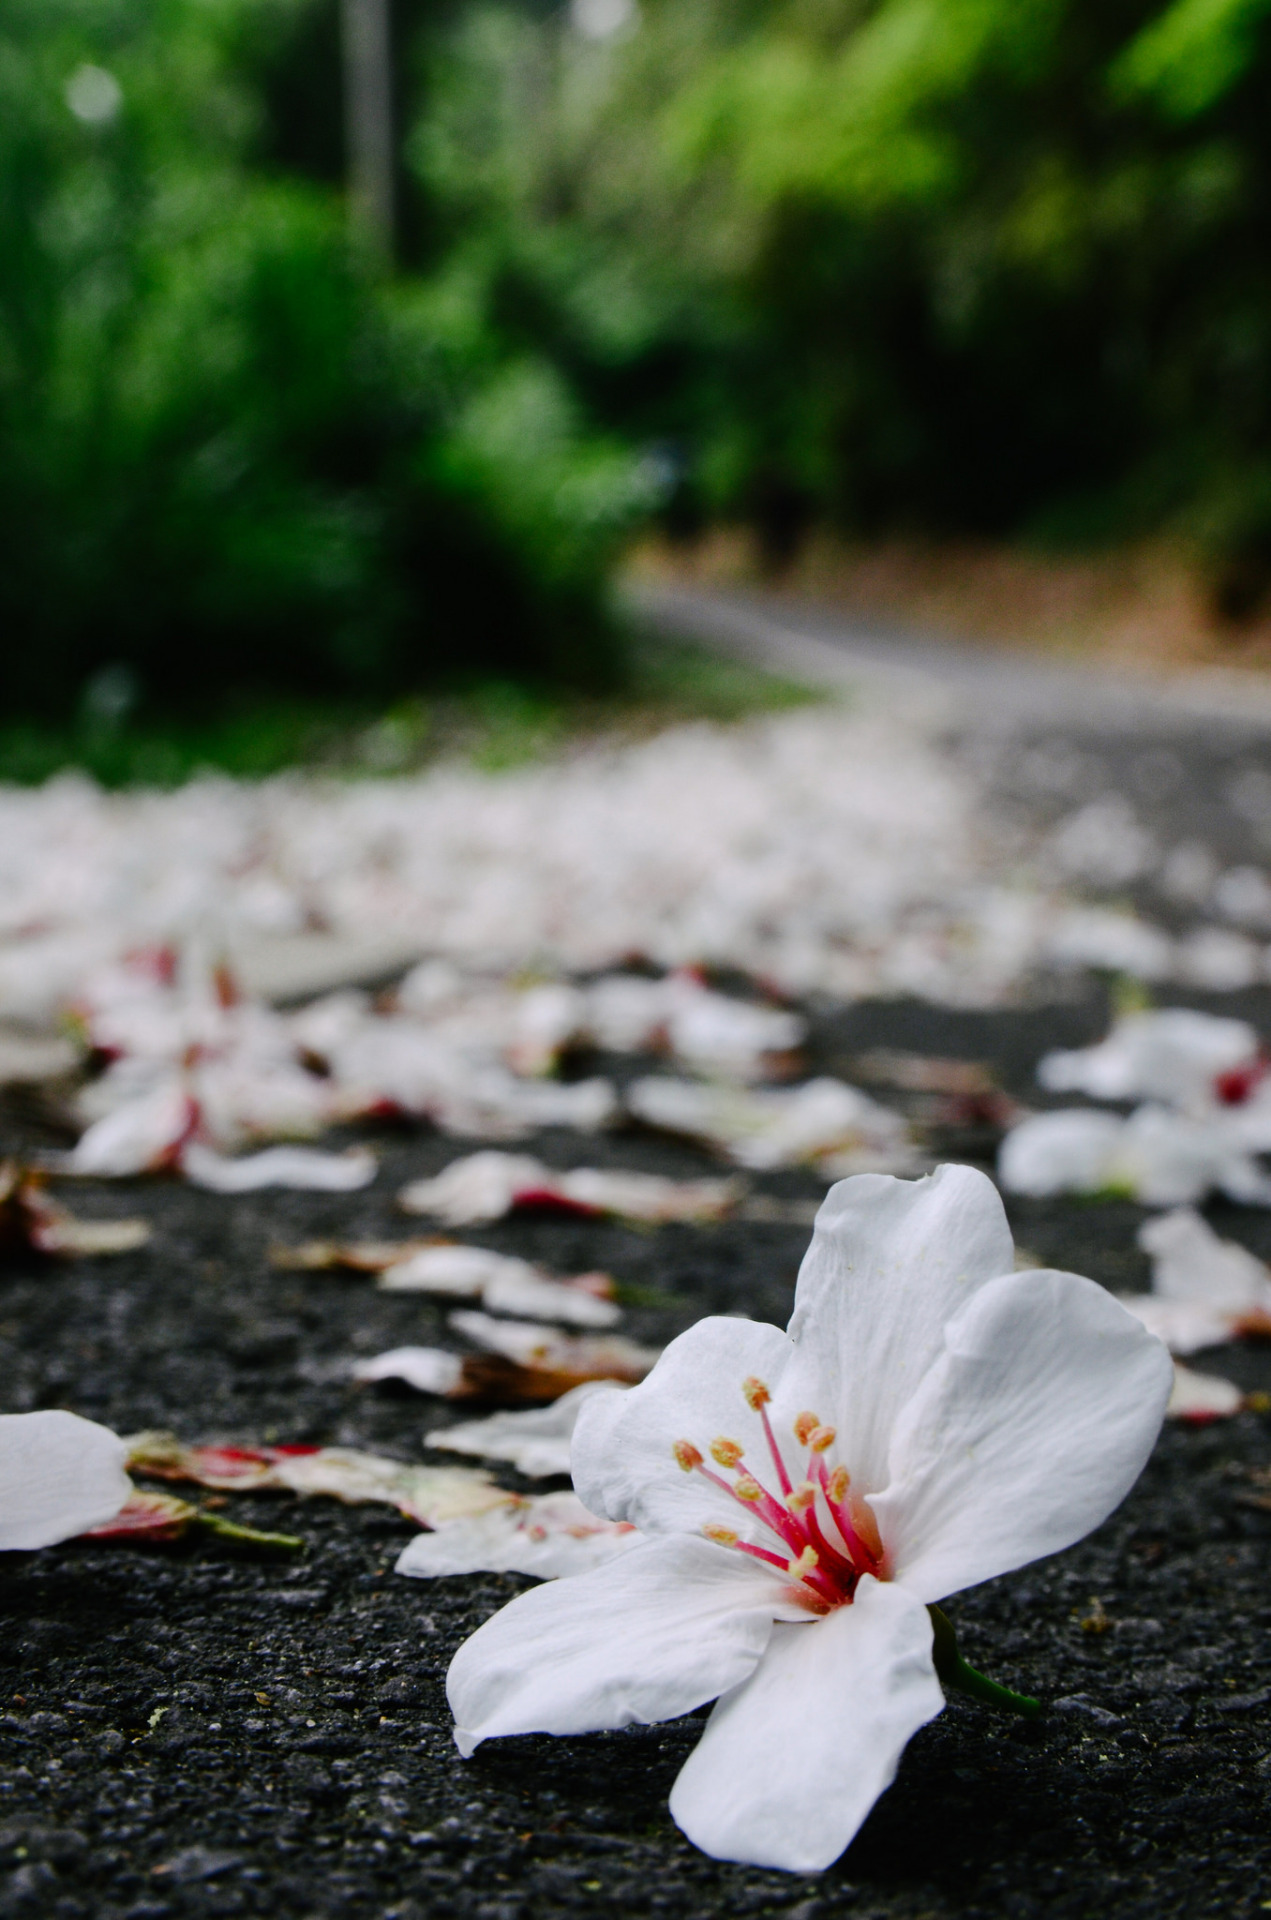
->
<box><xmin>670</xmin><ymin>1574</ymin><xmax>945</xmax><ymax>1874</ymax></box>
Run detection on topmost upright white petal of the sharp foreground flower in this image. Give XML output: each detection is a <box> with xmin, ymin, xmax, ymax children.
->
<box><xmin>775</xmin><ymin>1167</ymin><xmax>1014</xmax><ymax>1492</ymax></box>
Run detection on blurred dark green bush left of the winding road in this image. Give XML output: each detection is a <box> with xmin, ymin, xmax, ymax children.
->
<box><xmin>0</xmin><ymin>0</ymin><xmax>647</xmax><ymax>712</ymax></box>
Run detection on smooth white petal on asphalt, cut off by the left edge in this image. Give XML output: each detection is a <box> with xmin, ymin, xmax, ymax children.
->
<box><xmin>0</xmin><ymin>1411</ymin><xmax>132</xmax><ymax>1553</ymax></box>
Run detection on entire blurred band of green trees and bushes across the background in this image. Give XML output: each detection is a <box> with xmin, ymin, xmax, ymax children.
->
<box><xmin>0</xmin><ymin>0</ymin><xmax>1271</xmax><ymax>772</ymax></box>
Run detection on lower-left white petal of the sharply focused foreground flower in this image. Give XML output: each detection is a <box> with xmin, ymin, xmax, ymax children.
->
<box><xmin>445</xmin><ymin>1538</ymin><xmax>791</xmax><ymax>1755</ymax></box>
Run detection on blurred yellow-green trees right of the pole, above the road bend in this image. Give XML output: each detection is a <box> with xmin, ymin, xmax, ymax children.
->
<box><xmin>413</xmin><ymin>0</ymin><xmax>1271</xmax><ymax>597</ymax></box>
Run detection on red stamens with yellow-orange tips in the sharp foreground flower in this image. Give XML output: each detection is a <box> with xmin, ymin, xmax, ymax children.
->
<box><xmin>672</xmin><ymin>1379</ymin><xmax>885</xmax><ymax>1613</ymax></box>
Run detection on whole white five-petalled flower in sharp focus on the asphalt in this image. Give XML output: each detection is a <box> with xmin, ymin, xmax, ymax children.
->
<box><xmin>449</xmin><ymin>1167</ymin><xmax>1171</xmax><ymax>1872</ymax></box>
